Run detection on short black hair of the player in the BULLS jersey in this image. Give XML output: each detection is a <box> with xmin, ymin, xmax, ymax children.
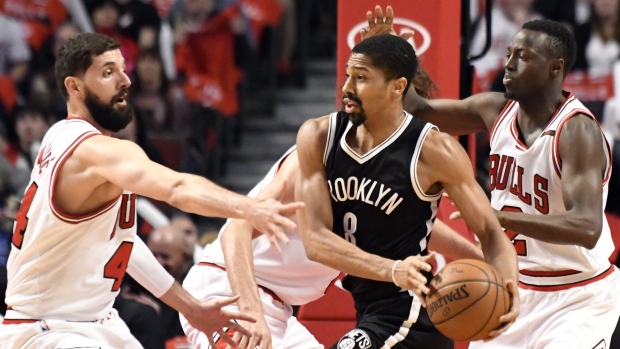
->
<box><xmin>521</xmin><ymin>19</ymin><xmax>577</xmax><ymax>76</ymax></box>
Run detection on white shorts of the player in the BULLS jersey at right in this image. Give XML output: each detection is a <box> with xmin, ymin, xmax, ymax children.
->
<box><xmin>469</xmin><ymin>267</ymin><xmax>620</xmax><ymax>349</ymax></box>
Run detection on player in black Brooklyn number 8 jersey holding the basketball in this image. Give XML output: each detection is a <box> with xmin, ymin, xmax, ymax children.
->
<box><xmin>295</xmin><ymin>35</ymin><xmax>519</xmax><ymax>348</ymax></box>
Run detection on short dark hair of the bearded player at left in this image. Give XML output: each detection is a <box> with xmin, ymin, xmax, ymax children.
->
<box><xmin>54</xmin><ymin>33</ymin><xmax>120</xmax><ymax>100</ymax></box>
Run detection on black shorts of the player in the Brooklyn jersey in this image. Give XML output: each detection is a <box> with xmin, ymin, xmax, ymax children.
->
<box><xmin>331</xmin><ymin>292</ymin><xmax>454</xmax><ymax>349</ymax></box>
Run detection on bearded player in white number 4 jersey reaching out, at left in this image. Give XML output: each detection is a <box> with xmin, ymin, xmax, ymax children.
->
<box><xmin>0</xmin><ymin>34</ymin><xmax>303</xmax><ymax>349</ymax></box>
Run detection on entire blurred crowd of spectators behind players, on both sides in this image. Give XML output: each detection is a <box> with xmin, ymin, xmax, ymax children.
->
<box><xmin>0</xmin><ymin>0</ymin><xmax>620</xmax><ymax>349</ymax></box>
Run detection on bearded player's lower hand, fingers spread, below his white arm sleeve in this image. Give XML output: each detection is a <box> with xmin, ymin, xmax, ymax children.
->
<box><xmin>183</xmin><ymin>296</ymin><xmax>256</xmax><ymax>348</ymax></box>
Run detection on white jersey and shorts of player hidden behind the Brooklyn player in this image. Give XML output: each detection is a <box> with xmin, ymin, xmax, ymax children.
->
<box><xmin>181</xmin><ymin>147</ymin><xmax>340</xmax><ymax>349</ymax></box>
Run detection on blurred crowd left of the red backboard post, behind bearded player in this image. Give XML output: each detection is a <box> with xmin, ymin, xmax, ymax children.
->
<box><xmin>0</xmin><ymin>0</ymin><xmax>336</xmax><ymax>348</ymax></box>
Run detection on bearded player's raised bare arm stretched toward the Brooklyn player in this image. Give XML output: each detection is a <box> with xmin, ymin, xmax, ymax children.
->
<box><xmin>72</xmin><ymin>136</ymin><xmax>303</xmax><ymax>242</ymax></box>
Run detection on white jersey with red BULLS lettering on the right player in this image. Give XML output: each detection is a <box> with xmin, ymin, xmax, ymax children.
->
<box><xmin>489</xmin><ymin>94</ymin><xmax>614</xmax><ymax>290</ymax></box>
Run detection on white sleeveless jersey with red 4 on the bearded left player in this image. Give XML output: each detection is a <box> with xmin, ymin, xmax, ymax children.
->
<box><xmin>6</xmin><ymin>119</ymin><xmax>136</xmax><ymax>321</ymax></box>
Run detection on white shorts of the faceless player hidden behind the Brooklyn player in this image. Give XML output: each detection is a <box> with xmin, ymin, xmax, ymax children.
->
<box><xmin>180</xmin><ymin>265</ymin><xmax>323</xmax><ymax>349</ymax></box>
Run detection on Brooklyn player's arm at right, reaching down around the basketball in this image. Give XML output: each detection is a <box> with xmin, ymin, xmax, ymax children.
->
<box><xmin>417</xmin><ymin>131</ymin><xmax>519</xmax><ymax>337</ymax></box>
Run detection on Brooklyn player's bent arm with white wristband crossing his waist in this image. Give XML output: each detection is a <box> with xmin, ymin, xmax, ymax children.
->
<box><xmin>295</xmin><ymin>118</ymin><xmax>431</xmax><ymax>293</ymax></box>
